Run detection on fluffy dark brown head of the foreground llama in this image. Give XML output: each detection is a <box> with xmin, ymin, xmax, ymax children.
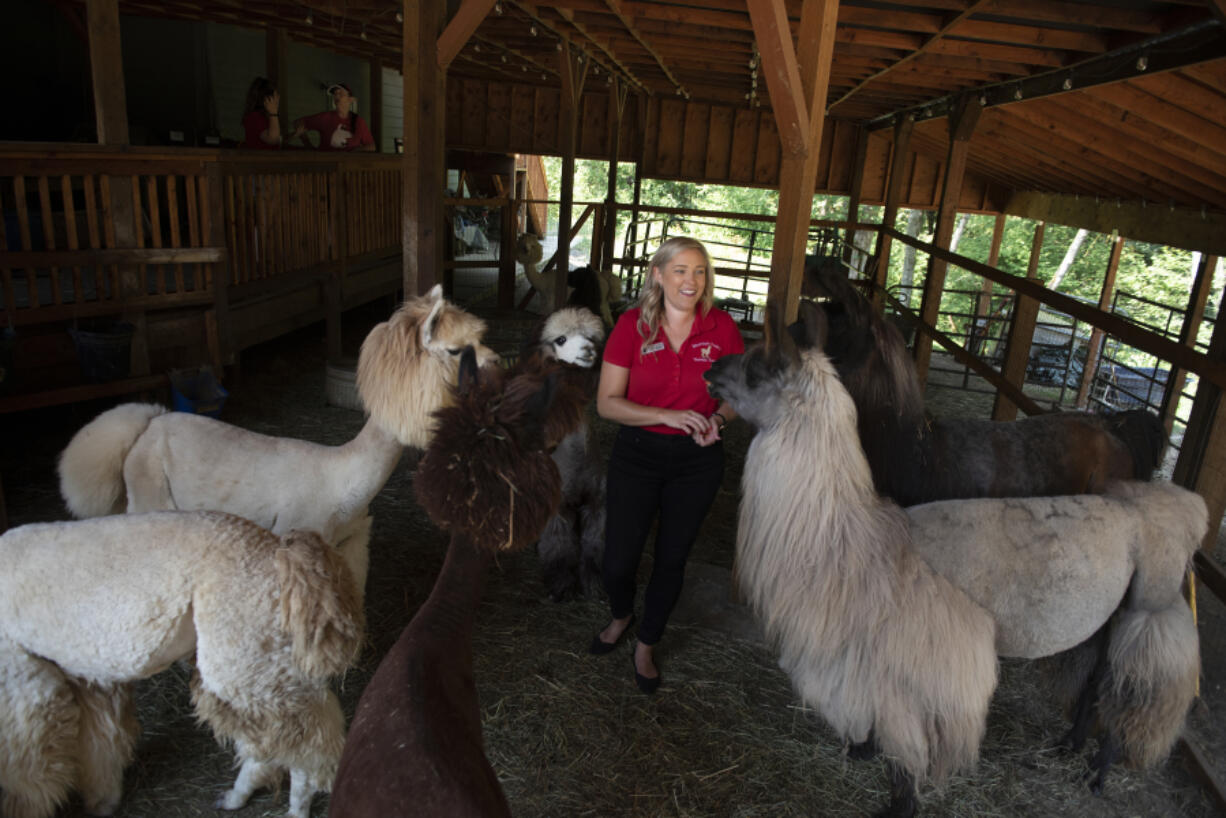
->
<box><xmin>413</xmin><ymin>353</ymin><xmax>562</xmax><ymax>551</ymax></box>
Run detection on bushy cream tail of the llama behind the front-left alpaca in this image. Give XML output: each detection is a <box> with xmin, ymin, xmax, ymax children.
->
<box><xmin>59</xmin><ymin>403</ymin><xmax>167</xmax><ymax>519</ymax></box>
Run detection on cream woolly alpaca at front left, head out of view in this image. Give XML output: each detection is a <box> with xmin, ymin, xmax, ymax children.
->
<box><xmin>0</xmin><ymin>511</ymin><xmax>364</xmax><ymax>818</ymax></box>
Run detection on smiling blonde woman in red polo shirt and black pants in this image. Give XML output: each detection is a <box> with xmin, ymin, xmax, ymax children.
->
<box><xmin>588</xmin><ymin>238</ymin><xmax>744</xmax><ymax>693</ymax></box>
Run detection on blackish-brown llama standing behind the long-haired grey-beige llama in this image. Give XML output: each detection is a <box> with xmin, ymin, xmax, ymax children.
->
<box><xmin>793</xmin><ymin>258</ymin><xmax>1166</xmax><ymax>506</ymax></box>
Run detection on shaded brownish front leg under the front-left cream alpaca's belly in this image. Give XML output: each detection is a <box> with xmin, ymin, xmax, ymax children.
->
<box><xmin>70</xmin><ymin>681</ymin><xmax>141</xmax><ymax>816</ymax></box>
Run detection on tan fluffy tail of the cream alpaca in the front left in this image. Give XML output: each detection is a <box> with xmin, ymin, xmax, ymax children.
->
<box><xmin>275</xmin><ymin>530</ymin><xmax>365</xmax><ymax>681</ymax></box>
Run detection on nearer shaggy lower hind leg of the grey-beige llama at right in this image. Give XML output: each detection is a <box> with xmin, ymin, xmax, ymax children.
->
<box><xmin>1098</xmin><ymin>598</ymin><xmax>1200</xmax><ymax>768</ymax></box>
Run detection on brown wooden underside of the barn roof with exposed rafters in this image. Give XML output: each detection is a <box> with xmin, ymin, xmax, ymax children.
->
<box><xmin>102</xmin><ymin>0</ymin><xmax>1226</xmax><ymax>217</ymax></box>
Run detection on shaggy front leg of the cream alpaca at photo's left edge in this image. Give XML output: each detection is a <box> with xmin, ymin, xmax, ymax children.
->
<box><xmin>0</xmin><ymin>652</ymin><xmax>80</xmax><ymax>818</ymax></box>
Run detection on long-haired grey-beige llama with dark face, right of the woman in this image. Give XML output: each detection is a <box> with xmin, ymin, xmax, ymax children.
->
<box><xmin>706</xmin><ymin>305</ymin><xmax>1208</xmax><ymax>814</ymax></box>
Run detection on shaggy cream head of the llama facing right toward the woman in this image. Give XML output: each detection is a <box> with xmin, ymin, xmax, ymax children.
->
<box><xmin>357</xmin><ymin>285</ymin><xmax>498</xmax><ymax>449</ymax></box>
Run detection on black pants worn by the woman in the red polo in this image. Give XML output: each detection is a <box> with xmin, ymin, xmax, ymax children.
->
<box><xmin>603</xmin><ymin>426</ymin><xmax>723</xmax><ymax>645</ymax></box>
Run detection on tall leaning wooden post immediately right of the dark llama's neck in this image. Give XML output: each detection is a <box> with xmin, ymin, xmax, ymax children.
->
<box><xmin>912</xmin><ymin>96</ymin><xmax>985</xmax><ymax>382</ymax></box>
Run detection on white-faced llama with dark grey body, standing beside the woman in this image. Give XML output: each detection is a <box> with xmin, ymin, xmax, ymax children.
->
<box><xmin>516</xmin><ymin>307</ymin><xmax>606</xmax><ymax>602</ymax></box>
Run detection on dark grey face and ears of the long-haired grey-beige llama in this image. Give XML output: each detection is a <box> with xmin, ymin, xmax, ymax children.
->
<box><xmin>704</xmin><ymin>302</ymin><xmax>834</xmax><ymax>428</ymax></box>
